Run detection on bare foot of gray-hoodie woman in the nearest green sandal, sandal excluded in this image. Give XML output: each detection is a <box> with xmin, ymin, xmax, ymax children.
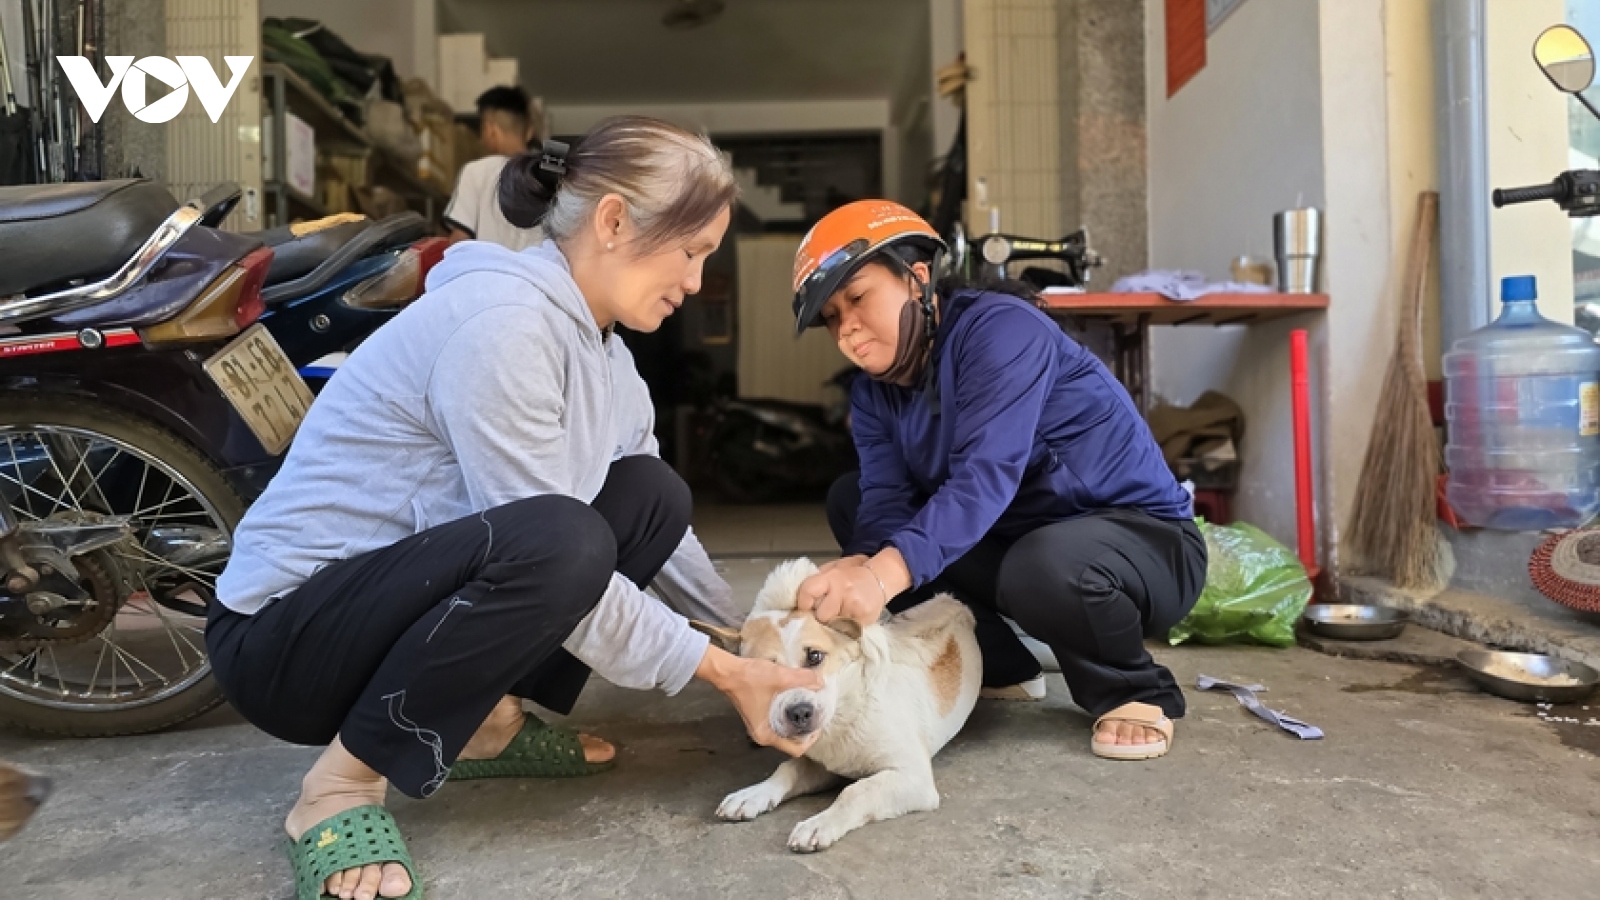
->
<box><xmin>283</xmin><ymin>738</ymin><xmax>411</xmax><ymax>900</ymax></box>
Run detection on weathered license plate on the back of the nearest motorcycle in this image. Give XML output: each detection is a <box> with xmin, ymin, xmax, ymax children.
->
<box><xmin>205</xmin><ymin>323</ymin><xmax>312</xmax><ymax>456</ymax></box>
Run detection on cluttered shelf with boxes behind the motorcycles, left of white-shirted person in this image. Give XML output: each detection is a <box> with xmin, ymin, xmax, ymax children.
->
<box><xmin>261</xmin><ymin>62</ymin><xmax>454</xmax><ymax>226</ymax></box>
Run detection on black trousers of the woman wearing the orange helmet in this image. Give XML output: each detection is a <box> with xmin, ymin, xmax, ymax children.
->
<box><xmin>827</xmin><ymin>472</ymin><xmax>1206</xmax><ymax>719</ymax></box>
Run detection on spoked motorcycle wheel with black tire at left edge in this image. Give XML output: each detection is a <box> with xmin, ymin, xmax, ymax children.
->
<box><xmin>0</xmin><ymin>396</ymin><xmax>245</xmax><ymax>737</ymax></box>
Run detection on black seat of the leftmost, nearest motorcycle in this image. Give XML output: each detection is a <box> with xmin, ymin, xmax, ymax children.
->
<box><xmin>0</xmin><ymin>178</ymin><xmax>178</xmax><ymax>296</ymax></box>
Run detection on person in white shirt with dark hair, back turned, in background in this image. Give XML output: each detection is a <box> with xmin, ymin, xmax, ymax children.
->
<box><xmin>445</xmin><ymin>86</ymin><xmax>544</xmax><ymax>250</ymax></box>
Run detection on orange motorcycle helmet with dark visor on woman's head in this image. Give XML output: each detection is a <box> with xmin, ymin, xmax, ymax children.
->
<box><xmin>794</xmin><ymin>200</ymin><xmax>946</xmax><ymax>335</ymax></box>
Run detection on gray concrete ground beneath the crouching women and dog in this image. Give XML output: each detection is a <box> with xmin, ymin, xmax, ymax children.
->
<box><xmin>0</xmin><ymin>538</ymin><xmax>1600</xmax><ymax>900</ymax></box>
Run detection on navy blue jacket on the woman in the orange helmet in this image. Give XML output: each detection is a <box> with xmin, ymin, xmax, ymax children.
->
<box><xmin>845</xmin><ymin>291</ymin><xmax>1194</xmax><ymax>586</ymax></box>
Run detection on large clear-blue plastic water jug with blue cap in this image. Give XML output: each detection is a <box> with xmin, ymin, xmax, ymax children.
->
<box><xmin>1445</xmin><ymin>275</ymin><xmax>1600</xmax><ymax>530</ymax></box>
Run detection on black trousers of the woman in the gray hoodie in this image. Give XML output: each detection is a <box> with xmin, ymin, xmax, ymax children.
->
<box><xmin>206</xmin><ymin>456</ymin><xmax>690</xmax><ymax>798</ymax></box>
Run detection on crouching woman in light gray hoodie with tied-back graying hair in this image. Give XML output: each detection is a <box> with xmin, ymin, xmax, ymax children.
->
<box><xmin>206</xmin><ymin>117</ymin><xmax>819</xmax><ymax>900</ymax></box>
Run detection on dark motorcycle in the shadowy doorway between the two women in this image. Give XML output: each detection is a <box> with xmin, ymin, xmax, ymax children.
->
<box><xmin>710</xmin><ymin>367</ymin><xmax>859</xmax><ymax>503</ymax></box>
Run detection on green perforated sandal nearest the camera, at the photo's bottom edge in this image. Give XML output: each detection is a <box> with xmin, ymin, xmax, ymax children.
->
<box><xmin>286</xmin><ymin>806</ymin><xmax>422</xmax><ymax>900</ymax></box>
